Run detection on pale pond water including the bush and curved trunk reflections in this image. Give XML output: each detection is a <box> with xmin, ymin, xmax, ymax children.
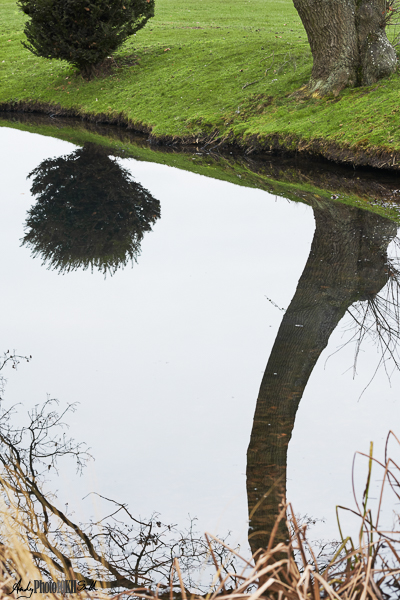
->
<box><xmin>0</xmin><ymin>127</ymin><xmax>400</xmax><ymax>576</ymax></box>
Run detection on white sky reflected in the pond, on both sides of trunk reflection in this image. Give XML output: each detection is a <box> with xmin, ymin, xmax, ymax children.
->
<box><xmin>0</xmin><ymin>128</ymin><xmax>400</xmax><ymax>552</ymax></box>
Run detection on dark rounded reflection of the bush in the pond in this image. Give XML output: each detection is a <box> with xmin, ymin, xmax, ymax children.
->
<box><xmin>22</xmin><ymin>144</ymin><xmax>160</xmax><ymax>273</ymax></box>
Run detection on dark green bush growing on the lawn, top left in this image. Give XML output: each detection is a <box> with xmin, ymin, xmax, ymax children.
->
<box><xmin>18</xmin><ymin>0</ymin><xmax>154</xmax><ymax>77</ymax></box>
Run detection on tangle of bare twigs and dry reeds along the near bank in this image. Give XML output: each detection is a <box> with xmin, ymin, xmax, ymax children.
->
<box><xmin>0</xmin><ymin>353</ymin><xmax>400</xmax><ymax>600</ymax></box>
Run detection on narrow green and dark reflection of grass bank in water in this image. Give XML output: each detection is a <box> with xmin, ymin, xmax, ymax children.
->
<box><xmin>0</xmin><ymin>116</ymin><xmax>400</xmax><ymax>222</ymax></box>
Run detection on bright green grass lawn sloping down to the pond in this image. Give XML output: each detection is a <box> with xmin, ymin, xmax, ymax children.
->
<box><xmin>0</xmin><ymin>0</ymin><xmax>400</xmax><ymax>167</ymax></box>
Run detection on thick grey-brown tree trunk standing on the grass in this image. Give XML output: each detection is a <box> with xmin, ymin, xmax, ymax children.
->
<box><xmin>293</xmin><ymin>0</ymin><xmax>397</xmax><ymax>96</ymax></box>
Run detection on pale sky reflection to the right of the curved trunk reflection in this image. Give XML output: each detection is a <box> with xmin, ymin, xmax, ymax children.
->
<box><xmin>287</xmin><ymin>310</ymin><xmax>400</xmax><ymax>538</ymax></box>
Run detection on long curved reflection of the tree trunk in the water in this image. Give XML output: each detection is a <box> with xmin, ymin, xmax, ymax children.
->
<box><xmin>247</xmin><ymin>204</ymin><xmax>396</xmax><ymax>553</ymax></box>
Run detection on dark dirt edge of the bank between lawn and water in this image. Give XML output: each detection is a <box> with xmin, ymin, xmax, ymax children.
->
<box><xmin>0</xmin><ymin>102</ymin><xmax>400</xmax><ymax>171</ymax></box>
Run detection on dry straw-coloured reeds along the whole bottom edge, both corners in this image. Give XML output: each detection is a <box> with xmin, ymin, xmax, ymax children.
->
<box><xmin>0</xmin><ymin>424</ymin><xmax>400</xmax><ymax>600</ymax></box>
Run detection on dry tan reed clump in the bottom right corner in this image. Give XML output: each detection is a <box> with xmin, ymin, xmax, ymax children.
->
<box><xmin>134</xmin><ymin>431</ymin><xmax>400</xmax><ymax>600</ymax></box>
